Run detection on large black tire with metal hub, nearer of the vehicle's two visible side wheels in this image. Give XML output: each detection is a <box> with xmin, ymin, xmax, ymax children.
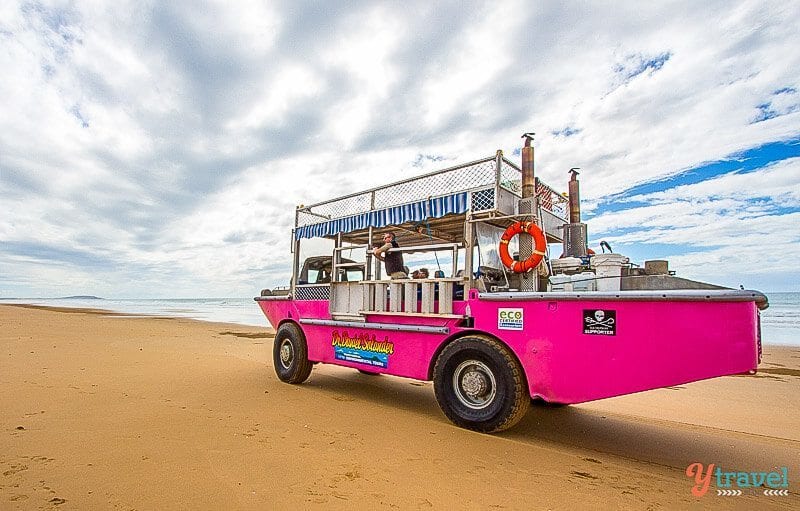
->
<box><xmin>433</xmin><ymin>335</ymin><xmax>531</xmax><ymax>433</ymax></box>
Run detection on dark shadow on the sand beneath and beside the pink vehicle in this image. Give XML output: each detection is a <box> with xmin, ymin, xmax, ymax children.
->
<box><xmin>296</xmin><ymin>368</ymin><xmax>800</xmax><ymax>473</ymax></box>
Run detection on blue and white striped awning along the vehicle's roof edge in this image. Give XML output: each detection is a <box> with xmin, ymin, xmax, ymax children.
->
<box><xmin>294</xmin><ymin>192</ymin><xmax>467</xmax><ymax>239</ymax></box>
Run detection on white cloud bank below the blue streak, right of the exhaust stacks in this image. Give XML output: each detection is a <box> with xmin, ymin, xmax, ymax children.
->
<box><xmin>590</xmin><ymin>158</ymin><xmax>800</xmax><ymax>289</ymax></box>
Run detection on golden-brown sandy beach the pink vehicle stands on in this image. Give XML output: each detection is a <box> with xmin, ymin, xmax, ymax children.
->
<box><xmin>0</xmin><ymin>305</ymin><xmax>800</xmax><ymax>510</ymax></box>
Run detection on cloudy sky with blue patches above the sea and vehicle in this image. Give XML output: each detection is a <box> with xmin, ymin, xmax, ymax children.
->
<box><xmin>0</xmin><ymin>0</ymin><xmax>800</xmax><ymax>298</ymax></box>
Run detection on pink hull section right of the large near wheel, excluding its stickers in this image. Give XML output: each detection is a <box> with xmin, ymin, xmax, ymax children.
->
<box><xmin>472</xmin><ymin>301</ymin><xmax>758</xmax><ymax>403</ymax></box>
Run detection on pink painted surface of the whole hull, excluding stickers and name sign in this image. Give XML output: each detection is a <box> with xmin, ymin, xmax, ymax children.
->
<box><xmin>258</xmin><ymin>298</ymin><xmax>758</xmax><ymax>403</ymax></box>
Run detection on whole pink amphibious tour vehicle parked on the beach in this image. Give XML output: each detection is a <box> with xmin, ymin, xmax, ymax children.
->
<box><xmin>255</xmin><ymin>134</ymin><xmax>767</xmax><ymax>432</ymax></box>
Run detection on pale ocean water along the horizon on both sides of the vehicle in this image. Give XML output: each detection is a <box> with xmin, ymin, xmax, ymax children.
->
<box><xmin>0</xmin><ymin>293</ymin><xmax>800</xmax><ymax>346</ymax></box>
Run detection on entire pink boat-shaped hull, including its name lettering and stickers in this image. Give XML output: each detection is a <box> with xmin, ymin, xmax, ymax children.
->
<box><xmin>257</xmin><ymin>291</ymin><xmax>763</xmax><ymax>403</ymax></box>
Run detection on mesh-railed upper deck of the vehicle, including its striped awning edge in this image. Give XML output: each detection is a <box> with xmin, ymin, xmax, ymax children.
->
<box><xmin>294</xmin><ymin>151</ymin><xmax>569</xmax><ymax>244</ymax></box>
